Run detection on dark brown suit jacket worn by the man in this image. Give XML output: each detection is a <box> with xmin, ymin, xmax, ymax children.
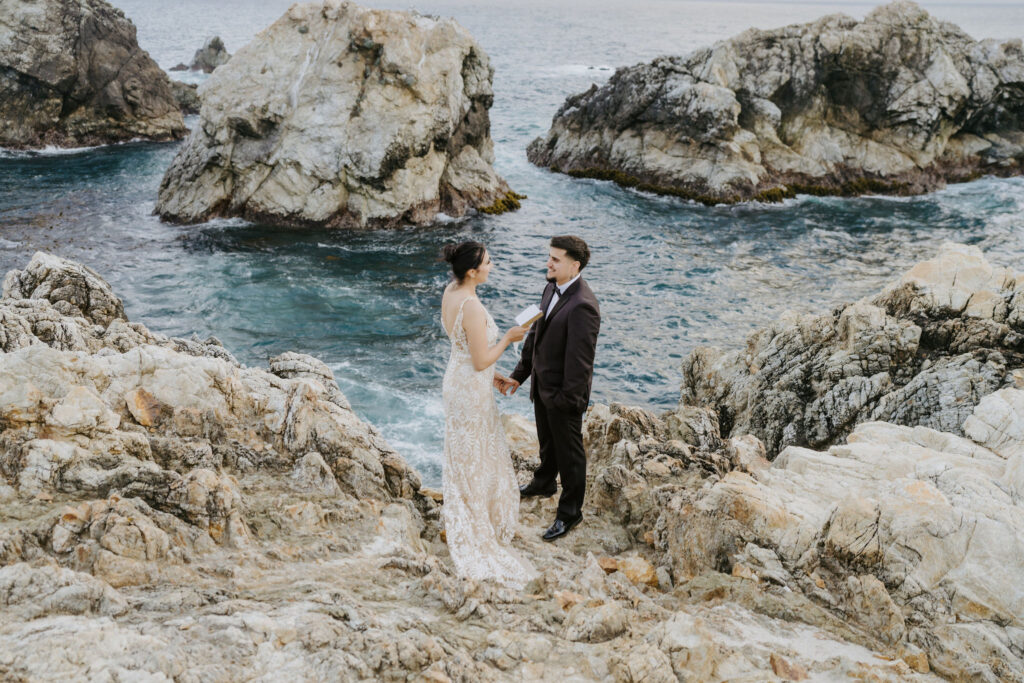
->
<box><xmin>511</xmin><ymin>278</ymin><xmax>601</xmax><ymax>415</ymax></box>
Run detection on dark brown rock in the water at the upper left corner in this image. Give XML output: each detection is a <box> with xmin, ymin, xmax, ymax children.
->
<box><xmin>0</xmin><ymin>0</ymin><xmax>186</xmax><ymax>148</ymax></box>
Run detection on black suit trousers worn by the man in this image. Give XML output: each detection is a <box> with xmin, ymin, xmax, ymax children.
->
<box><xmin>532</xmin><ymin>396</ymin><xmax>587</xmax><ymax>521</ymax></box>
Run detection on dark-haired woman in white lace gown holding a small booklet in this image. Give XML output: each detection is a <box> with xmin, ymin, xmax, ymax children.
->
<box><xmin>441</xmin><ymin>242</ymin><xmax>537</xmax><ymax>588</ymax></box>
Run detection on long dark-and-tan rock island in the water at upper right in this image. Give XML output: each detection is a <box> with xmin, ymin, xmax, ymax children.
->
<box><xmin>527</xmin><ymin>0</ymin><xmax>1024</xmax><ymax>204</ymax></box>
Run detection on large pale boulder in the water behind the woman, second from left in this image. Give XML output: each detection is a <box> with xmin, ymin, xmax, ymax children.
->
<box><xmin>157</xmin><ymin>0</ymin><xmax>518</xmax><ymax>227</ymax></box>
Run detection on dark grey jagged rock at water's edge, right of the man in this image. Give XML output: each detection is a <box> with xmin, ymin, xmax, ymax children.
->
<box><xmin>670</xmin><ymin>243</ymin><xmax>1024</xmax><ymax>458</ymax></box>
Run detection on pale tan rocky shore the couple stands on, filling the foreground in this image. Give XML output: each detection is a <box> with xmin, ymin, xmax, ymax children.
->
<box><xmin>0</xmin><ymin>246</ymin><xmax>1024</xmax><ymax>681</ymax></box>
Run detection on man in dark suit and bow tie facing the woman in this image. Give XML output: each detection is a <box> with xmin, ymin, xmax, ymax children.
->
<box><xmin>496</xmin><ymin>236</ymin><xmax>601</xmax><ymax>541</ymax></box>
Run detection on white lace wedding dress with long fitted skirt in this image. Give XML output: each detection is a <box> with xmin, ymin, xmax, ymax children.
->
<box><xmin>441</xmin><ymin>297</ymin><xmax>537</xmax><ymax>588</ymax></box>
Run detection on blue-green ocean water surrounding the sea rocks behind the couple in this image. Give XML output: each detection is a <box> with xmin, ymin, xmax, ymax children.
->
<box><xmin>0</xmin><ymin>0</ymin><xmax>1024</xmax><ymax>484</ymax></box>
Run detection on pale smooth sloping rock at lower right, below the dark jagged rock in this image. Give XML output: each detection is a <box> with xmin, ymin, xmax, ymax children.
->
<box><xmin>660</xmin><ymin>388</ymin><xmax>1024</xmax><ymax>680</ymax></box>
